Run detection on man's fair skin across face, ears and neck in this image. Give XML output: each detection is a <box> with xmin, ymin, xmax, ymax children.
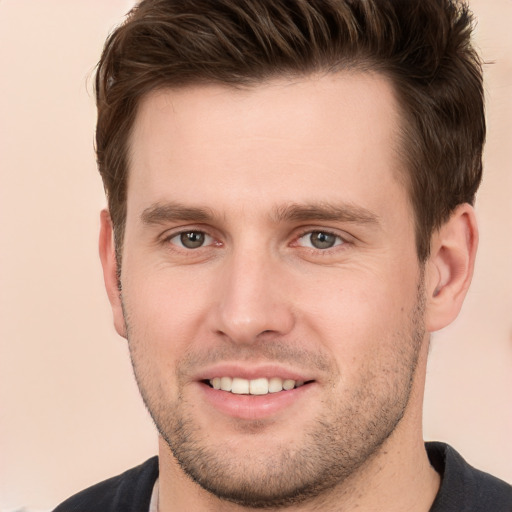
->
<box><xmin>100</xmin><ymin>73</ymin><xmax>477</xmax><ymax>512</ymax></box>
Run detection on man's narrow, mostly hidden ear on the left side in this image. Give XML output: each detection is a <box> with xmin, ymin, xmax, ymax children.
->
<box><xmin>99</xmin><ymin>210</ymin><xmax>126</xmax><ymax>338</ymax></box>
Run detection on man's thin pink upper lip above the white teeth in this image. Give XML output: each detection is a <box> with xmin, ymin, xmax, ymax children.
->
<box><xmin>194</xmin><ymin>363</ymin><xmax>315</xmax><ymax>382</ymax></box>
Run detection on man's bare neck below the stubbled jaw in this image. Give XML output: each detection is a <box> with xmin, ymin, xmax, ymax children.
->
<box><xmin>158</xmin><ymin>432</ymin><xmax>440</xmax><ymax>512</ymax></box>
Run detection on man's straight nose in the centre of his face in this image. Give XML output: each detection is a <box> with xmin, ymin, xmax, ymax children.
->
<box><xmin>211</xmin><ymin>248</ymin><xmax>295</xmax><ymax>344</ymax></box>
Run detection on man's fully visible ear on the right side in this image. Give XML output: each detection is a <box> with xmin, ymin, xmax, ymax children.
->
<box><xmin>425</xmin><ymin>203</ymin><xmax>478</xmax><ymax>332</ymax></box>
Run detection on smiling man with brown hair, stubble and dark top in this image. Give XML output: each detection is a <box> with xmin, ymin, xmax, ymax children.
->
<box><xmin>56</xmin><ymin>0</ymin><xmax>512</xmax><ymax>512</ymax></box>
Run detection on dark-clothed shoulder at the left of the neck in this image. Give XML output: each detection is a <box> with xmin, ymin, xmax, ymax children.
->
<box><xmin>53</xmin><ymin>456</ymin><xmax>158</xmax><ymax>512</ymax></box>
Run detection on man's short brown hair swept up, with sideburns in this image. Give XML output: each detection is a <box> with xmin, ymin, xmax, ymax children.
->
<box><xmin>96</xmin><ymin>0</ymin><xmax>485</xmax><ymax>262</ymax></box>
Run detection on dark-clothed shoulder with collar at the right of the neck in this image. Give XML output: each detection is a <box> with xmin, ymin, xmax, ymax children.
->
<box><xmin>426</xmin><ymin>443</ymin><xmax>512</xmax><ymax>512</ymax></box>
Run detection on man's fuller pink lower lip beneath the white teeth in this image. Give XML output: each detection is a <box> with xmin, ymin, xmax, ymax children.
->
<box><xmin>198</xmin><ymin>382</ymin><xmax>315</xmax><ymax>421</ymax></box>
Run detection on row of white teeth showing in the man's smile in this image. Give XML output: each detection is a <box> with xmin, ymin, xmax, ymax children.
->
<box><xmin>203</xmin><ymin>377</ymin><xmax>313</xmax><ymax>395</ymax></box>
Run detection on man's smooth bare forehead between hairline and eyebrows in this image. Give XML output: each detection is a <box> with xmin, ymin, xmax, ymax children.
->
<box><xmin>128</xmin><ymin>72</ymin><xmax>408</xmax><ymax>222</ymax></box>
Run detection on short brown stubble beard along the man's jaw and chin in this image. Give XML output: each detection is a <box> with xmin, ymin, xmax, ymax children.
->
<box><xmin>125</xmin><ymin>280</ymin><xmax>425</xmax><ymax>509</ymax></box>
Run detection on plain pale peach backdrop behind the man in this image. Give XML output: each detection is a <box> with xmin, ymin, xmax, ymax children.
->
<box><xmin>0</xmin><ymin>0</ymin><xmax>512</xmax><ymax>510</ymax></box>
